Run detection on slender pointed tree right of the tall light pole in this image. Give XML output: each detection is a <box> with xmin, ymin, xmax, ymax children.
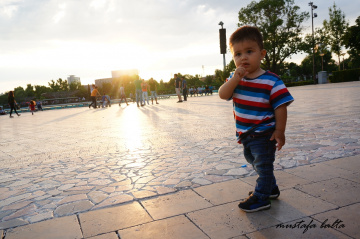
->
<box><xmin>323</xmin><ymin>3</ymin><xmax>349</xmax><ymax>70</ymax></box>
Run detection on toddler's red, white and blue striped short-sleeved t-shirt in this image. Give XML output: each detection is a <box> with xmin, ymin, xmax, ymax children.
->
<box><xmin>228</xmin><ymin>71</ymin><xmax>294</xmax><ymax>142</ymax></box>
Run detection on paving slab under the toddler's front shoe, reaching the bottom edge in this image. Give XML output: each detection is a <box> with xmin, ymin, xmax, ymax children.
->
<box><xmin>187</xmin><ymin>202</ymin><xmax>280</xmax><ymax>239</ymax></box>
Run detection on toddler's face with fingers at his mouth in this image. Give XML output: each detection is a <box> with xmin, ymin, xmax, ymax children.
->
<box><xmin>232</xmin><ymin>40</ymin><xmax>266</xmax><ymax>78</ymax></box>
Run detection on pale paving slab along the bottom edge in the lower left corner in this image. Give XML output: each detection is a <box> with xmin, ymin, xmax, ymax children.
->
<box><xmin>6</xmin><ymin>216</ymin><xmax>82</xmax><ymax>239</ymax></box>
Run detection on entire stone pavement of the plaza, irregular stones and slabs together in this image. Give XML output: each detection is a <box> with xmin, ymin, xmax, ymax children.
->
<box><xmin>0</xmin><ymin>82</ymin><xmax>360</xmax><ymax>239</ymax></box>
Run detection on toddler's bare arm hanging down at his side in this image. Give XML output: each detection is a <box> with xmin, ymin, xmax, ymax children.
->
<box><xmin>270</xmin><ymin>104</ymin><xmax>287</xmax><ymax>150</ymax></box>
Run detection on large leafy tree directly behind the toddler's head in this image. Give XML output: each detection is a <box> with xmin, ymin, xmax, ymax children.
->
<box><xmin>238</xmin><ymin>0</ymin><xmax>309</xmax><ymax>73</ymax></box>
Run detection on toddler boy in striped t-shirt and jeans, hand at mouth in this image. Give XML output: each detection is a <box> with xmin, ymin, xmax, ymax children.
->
<box><xmin>219</xmin><ymin>26</ymin><xmax>294</xmax><ymax>212</ymax></box>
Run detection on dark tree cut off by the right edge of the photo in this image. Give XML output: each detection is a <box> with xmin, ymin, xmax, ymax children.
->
<box><xmin>344</xmin><ymin>16</ymin><xmax>360</xmax><ymax>68</ymax></box>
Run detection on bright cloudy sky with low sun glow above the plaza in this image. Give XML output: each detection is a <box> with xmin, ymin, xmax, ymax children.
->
<box><xmin>0</xmin><ymin>0</ymin><xmax>360</xmax><ymax>93</ymax></box>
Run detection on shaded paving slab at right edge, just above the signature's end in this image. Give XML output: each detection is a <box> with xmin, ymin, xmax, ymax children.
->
<box><xmin>296</xmin><ymin>178</ymin><xmax>360</xmax><ymax>206</ymax></box>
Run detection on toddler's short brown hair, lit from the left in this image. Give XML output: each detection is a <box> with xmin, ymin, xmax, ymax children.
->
<box><xmin>229</xmin><ymin>26</ymin><xmax>264</xmax><ymax>51</ymax></box>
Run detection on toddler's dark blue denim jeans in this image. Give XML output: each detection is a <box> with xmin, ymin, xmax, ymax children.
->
<box><xmin>241</xmin><ymin>134</ymin><xmax>276</xmax><ymax>200</ymax></box>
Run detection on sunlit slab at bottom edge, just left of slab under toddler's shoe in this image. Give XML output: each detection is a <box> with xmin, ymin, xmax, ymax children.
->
<box><xmin>118</xmin><ymin>216</ymin><xmax>208</xmax><ymax>239</ymax></box>
